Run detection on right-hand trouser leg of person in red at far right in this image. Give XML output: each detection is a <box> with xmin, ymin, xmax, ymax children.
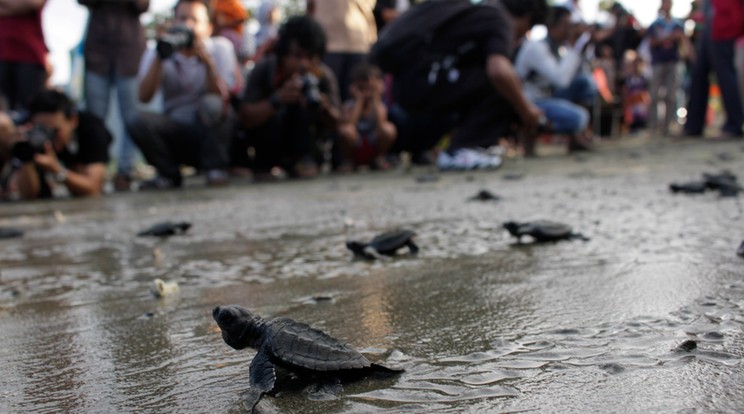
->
<box><xmin>711</xmin><ymin>40</ymin><xmax>744</xmax><ymax>136</ymax></box>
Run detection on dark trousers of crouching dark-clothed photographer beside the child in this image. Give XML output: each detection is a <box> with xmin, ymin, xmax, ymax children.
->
<box><xmin>245</xmin><ymin>105</ymin><xmax>321</xmax><ymax>172</ymax></box>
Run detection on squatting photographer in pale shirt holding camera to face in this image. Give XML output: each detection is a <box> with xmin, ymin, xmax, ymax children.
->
<box><xmin>129</xmin><ymin>0</ymin><xmax>237</xmax><ymax>190</ymax></box>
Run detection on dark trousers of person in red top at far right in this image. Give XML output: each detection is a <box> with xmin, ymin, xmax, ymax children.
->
<box><xmin>685</xmin><ymin>30</ymin><xmax>744</xmax><ymax>135</ymax></box>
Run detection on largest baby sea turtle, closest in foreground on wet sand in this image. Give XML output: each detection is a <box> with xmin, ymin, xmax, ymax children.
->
<box><xmin>212</xmin><ymin>305</ymin><xmax>401</xmax><ymax>409</ymax></box>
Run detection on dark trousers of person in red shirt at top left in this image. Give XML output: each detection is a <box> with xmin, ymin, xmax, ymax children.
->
<box><xmin>0</xmin><ymin>62</ymin><xmax>46</xmax><ymax>111</ymax></box>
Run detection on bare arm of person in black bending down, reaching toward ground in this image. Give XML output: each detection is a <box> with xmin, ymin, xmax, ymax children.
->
<box><xmin>486</xmin><ymin>54</ymin><xmax>542</xmax><ymax>132</ymax></box>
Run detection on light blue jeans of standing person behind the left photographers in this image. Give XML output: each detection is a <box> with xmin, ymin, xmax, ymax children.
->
<box><xmin>85</xmin><ymin>71</ymin><xmax>138</xmax><ymax>175</ymax></box>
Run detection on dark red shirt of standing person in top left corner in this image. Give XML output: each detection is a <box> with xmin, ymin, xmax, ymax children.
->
<box><xmin>0</xmin><ymin>9</ymin><xmax>49</xmax><ymax>66</ymax></box>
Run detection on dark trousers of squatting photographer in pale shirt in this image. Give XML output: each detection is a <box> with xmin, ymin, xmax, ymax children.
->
<box><xmin>128</xmin><ymin>112</ymin><xmax>227</xmax><ymax>185</ymax></box>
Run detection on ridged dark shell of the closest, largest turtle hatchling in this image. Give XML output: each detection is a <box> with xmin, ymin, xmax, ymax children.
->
<box><xmin>263</xmin><ymin>318</ymin><xmax>372</xmax><ymax>371</ymax></box>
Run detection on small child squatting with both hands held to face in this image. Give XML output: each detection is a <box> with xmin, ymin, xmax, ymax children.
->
<box><xmin>337</xmin><ymin>63</ymin><xmax>397</xmax><ymax>172</ymax></box>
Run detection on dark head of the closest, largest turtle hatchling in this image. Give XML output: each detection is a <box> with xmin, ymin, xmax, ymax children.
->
<box><xmin>212</xmin><ymin>305</ymin><xmax>263</xmax><ymax>349</ymax></box>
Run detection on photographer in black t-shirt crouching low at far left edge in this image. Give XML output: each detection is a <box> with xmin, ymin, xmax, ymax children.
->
<box><xmin>2</xmin><ymin>90</ymin><xmax>111</xmax><ymax>199</ymax></box>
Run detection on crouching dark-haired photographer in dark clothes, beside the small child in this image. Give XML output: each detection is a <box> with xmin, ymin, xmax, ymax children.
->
<box><xmin>240</xmin><ymin>16</ymin><xmax>340</xmax><ymax>178</ymax></box>
